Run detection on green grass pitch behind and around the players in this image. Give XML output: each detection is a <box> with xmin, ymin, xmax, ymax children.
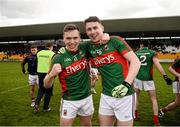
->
<box><xmin>0</xmin><ymin>62</ymin><xmax>180</xmax><ymax>126</ymax></box>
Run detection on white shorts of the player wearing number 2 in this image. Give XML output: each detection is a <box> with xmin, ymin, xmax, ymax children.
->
<box><xmin>133</xmin><ymin>79</ymin><xmax>156</xmax><ymax>91</ymax></box>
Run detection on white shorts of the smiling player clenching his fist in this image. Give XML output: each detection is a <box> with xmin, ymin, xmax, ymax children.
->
<box><xmin>60</xmin><ymin>95</ymin><xmax>94</xmax><ymax>119</ymax></box>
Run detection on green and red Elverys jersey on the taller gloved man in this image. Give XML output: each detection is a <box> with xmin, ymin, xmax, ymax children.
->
<box><xmin>89</xmin><ymin>36</ymin><xmax>134</xmax><ymax>96</ymax></box>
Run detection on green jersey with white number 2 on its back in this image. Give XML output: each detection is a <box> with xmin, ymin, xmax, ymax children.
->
<box><xmin>136</xmin><ymin>47</ymin><xmax>156</xmax><ymax>81</ymax></box>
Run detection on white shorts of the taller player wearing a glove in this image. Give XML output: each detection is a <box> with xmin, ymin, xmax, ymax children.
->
<box><xmin>99</xmin><ymin>94</ymin><xmax>135</xmax><ymax>121</ymax></box>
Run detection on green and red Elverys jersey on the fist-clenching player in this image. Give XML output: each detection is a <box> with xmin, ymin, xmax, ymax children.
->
<box><xmin>52</xmin><ymin>43</ymin><xmax>90</xmax><ymax>100</ymax></box>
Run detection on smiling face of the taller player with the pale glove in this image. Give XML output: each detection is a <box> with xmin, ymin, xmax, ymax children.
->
<box><xmin>86</xmin><ymin>22</ymin><xmax>104</xmax><ymax>43</ymax></box>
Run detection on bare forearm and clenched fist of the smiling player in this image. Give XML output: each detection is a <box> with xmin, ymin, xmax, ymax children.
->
<box><xmin>44</xmin><ymin>64</ymin><xmax>62</xmax><ymax>88</ymax></box>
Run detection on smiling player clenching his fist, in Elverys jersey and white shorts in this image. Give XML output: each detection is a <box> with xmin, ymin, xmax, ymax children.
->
<box><xmin>44</xmin><ymin>24</ymin><xmax>94</xmax><ymax>126</ymax></box>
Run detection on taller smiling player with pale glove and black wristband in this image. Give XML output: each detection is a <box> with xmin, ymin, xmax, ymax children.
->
<box><xmin>84</xmin><ymin>16</ymin><xmax>140</xmax><ymax>126</ymax></box>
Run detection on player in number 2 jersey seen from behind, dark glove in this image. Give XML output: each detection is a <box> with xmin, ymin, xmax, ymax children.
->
<box><xmin>134</xmin><ymin>40</ymin><xmax>172</xmax><ymax>125</ymax></box>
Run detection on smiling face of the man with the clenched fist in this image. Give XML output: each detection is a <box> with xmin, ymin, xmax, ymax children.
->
<box><xmin>63</xmin><ymin>30</ymin><xmax>80</xmax><ymax>52</ymax></box>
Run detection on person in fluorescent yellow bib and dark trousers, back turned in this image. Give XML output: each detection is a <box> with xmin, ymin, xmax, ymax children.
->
<box><xmin>34</xmin><ymin>42</ymin><xmax>55</xmax><ymax>112</ymax></box>
